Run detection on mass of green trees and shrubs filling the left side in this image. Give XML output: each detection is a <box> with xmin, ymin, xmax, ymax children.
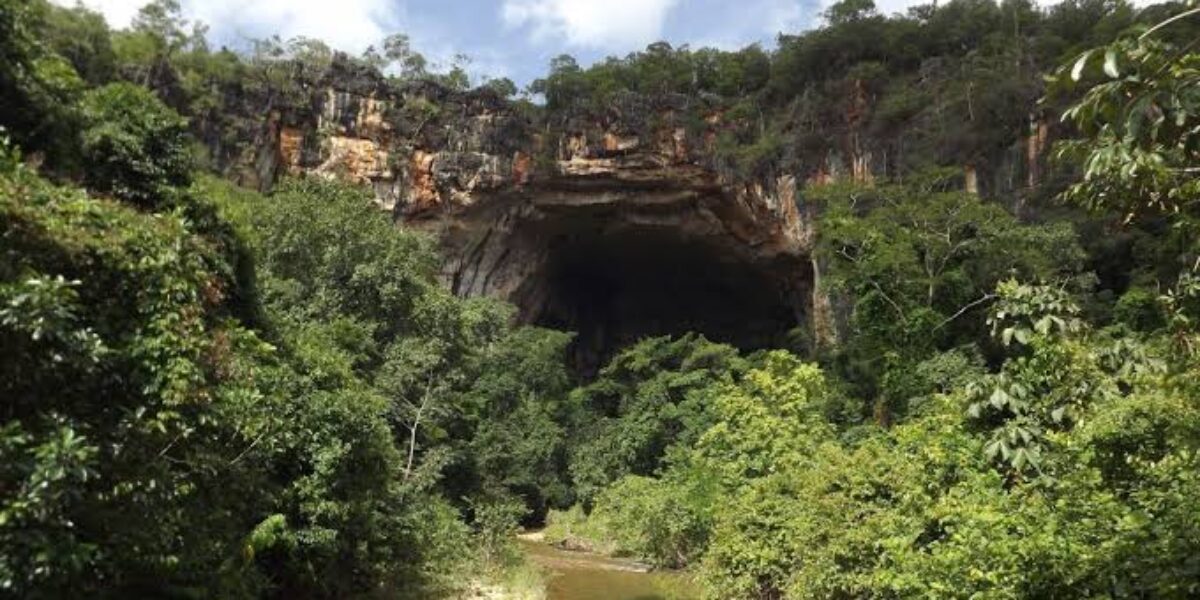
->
<box><xmin>0</xmin><ymin>2</ymin><xmax>569</xmax><ymax>598</ymax></box>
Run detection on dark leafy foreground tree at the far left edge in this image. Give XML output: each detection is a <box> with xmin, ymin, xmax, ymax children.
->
<box><xmin>0</xmin><ymin>139</ymin><xmax>280</xmax><ymax>598</ymax></box>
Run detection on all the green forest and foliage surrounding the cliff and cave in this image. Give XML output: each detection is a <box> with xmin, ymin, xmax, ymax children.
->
<box><xmin>0</xmin><ymin>0</ymin><xmax>1200</xmax><ymax>599</ymax></box>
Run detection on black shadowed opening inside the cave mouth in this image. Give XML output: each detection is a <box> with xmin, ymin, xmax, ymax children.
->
<box><xmin>514</xmin><ymin>211</ymin><xmax>810</xmax><ymax>377</ymax></box>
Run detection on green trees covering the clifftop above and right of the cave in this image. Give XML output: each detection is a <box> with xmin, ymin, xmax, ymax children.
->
<box><xmin>530</xmin><ymin>0</ymin><xmax>1195</xmax><ymax>188</ymax></box>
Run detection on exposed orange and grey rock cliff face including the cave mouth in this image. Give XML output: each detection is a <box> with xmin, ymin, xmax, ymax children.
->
<box><xmin>250</xmin><ymin>58</ymin><xmax>814</xmax><ymax>370</ymax></box>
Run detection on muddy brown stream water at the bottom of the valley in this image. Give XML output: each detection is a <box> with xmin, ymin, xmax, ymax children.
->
<box><xmin>521</xmin><ymin>540</ymin><xmax>700</xmax><ymax>600</ymax></box>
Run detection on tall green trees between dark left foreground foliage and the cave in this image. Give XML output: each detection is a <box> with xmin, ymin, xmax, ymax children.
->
<box><xmin>199</xmin><ymin>179</ymin><xmax>508</xmax><ymax>598</ymax></box>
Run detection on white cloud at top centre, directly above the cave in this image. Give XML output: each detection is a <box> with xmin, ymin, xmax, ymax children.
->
<box><xmin>500</xmin><ymin>0</ymin><xmax>677</xmax><ymax>49</ymax></box>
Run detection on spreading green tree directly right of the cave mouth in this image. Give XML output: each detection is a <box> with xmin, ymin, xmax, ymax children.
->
<box><xmin>810</xmin><ymin>178</ymin><xmax>1084</xmax><ymax>424</ymax></box>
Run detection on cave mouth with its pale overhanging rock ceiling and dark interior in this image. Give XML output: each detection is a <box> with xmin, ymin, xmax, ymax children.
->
<box><xmin>436</xmin><ymin>161</ymin><xmax>812</xmax><ymax>373</ymax></box>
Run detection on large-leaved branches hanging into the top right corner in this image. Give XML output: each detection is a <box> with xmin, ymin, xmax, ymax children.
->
<box><xmin>1057</xmin><ymin>8</ymin><xmax>1200</xmax><ymax>221</ymax></box>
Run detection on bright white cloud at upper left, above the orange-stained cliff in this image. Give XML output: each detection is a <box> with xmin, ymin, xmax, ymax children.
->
<box><xmin>54</xmin><ymin>0</ymin><xmax>403</xmax><ymax>52</ymax></box>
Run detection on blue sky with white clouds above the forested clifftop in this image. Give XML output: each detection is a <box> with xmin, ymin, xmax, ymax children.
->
<box><xmin>54</xmin><ymin>0</ymin><xmax>1099</xmax><ymax>85</ymax></box>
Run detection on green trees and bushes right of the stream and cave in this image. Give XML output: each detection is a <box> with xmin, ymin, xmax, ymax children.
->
<box><xmin>550</xmin><ymin>11</ymin><xmax>1200</xmax><ymax>598</ymax></box>
